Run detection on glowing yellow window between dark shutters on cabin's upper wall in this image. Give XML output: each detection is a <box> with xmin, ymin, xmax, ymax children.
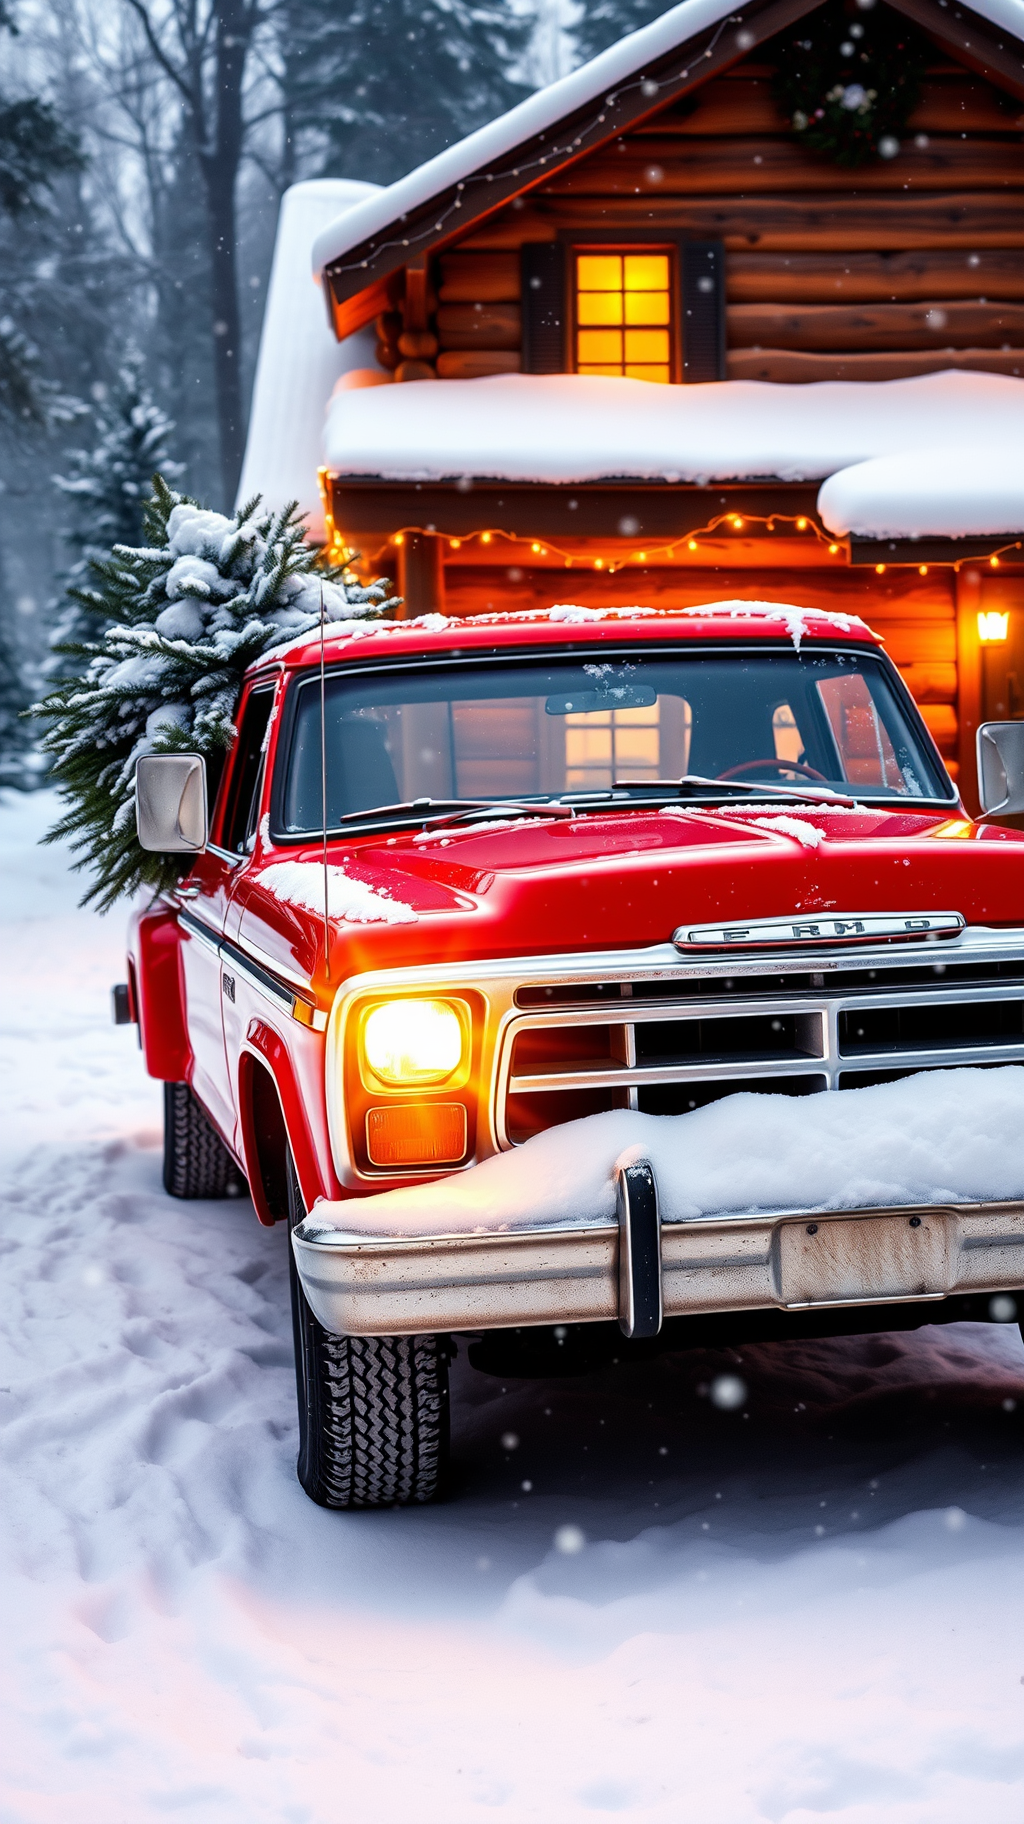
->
<box><xmin>575</xmin><ymin>254</ymin><xmax>672</xmax><ymax>385</ymax></box>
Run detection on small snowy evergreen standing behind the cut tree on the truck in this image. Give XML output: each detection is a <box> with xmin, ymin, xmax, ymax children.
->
<box><xmin>51</xmin><ymin>350</ymin><xmax>183</xmax><ymax>673</ymax></box>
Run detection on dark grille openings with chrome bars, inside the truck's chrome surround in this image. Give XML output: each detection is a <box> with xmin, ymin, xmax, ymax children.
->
<box><xmin>498</xmin><ymin>963</ymin><xmax>1024</xmax><ymax>1145</ymax></box>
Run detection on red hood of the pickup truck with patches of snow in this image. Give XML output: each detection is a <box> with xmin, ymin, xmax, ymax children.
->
<box><xmin>228</xmin><ymin>801</ymin><xmax>1024</xmax><ymax>981</ymax></box>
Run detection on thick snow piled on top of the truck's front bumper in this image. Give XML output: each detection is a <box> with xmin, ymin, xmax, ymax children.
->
<box><xmin>305</xmin><ymin>1065</ymin><xmax>1024</xmax><ymax>1237</ymax></box>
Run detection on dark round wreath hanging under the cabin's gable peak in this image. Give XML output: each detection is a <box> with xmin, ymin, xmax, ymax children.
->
<box><xmin>774</xmin><ymin>0</ymin><xmax>929</xmax><ymax>170</ymax></box>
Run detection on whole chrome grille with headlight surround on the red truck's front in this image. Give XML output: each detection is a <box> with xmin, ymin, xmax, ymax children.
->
<box><xmin>327</xmin><ymin>927</ymin><xmax>1024</xmax><ymax>1187</ymax></box>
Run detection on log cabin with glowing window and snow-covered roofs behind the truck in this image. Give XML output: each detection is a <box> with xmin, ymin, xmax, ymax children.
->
<box><xmin>235</xmin><ymin>0</ymin><xmax>1024</xmax><ymax>813</ymax></box>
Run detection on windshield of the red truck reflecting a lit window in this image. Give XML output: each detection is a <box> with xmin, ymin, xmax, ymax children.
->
<box><xmin>274</xmin><ymin>648</ymin><xmax>953</xmax><ymax>835</ymax></box>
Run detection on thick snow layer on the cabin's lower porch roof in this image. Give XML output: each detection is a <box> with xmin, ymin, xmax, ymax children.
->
<box><xmin>325</xmin><ymin>370</ymin><xmax>1024</xmax><ymax>538</ymax></box>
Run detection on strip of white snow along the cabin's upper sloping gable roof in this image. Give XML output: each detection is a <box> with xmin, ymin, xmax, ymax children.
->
<box><xmin>312</xmin><ymin>0</ymin><xmax>1024</xmax><ymax>275</ymax></box>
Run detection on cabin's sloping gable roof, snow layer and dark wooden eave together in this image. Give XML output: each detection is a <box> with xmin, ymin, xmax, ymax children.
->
<box><xmin>312</xmin><ymin>0</ymin><xmax>1024</xmax><ymax>334</ymax></box>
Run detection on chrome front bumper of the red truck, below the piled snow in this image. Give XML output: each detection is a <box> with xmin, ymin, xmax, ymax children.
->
<box><xmin>284</xmin><ymin>1162</ymin><xmax>1024</xmax><ymax>1335</ymax></box>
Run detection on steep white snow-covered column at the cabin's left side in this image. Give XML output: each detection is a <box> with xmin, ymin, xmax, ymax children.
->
<box><xmin>237</xmin><ymin>177</ymin><xmax>380</xmax><ymax>538</ymax></box>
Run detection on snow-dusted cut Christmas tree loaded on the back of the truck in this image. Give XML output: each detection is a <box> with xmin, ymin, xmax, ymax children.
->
<box><xmin>31</xmin><ymin>476</ymin><xmax>389</xmax><ymax>910</ymax></box>
